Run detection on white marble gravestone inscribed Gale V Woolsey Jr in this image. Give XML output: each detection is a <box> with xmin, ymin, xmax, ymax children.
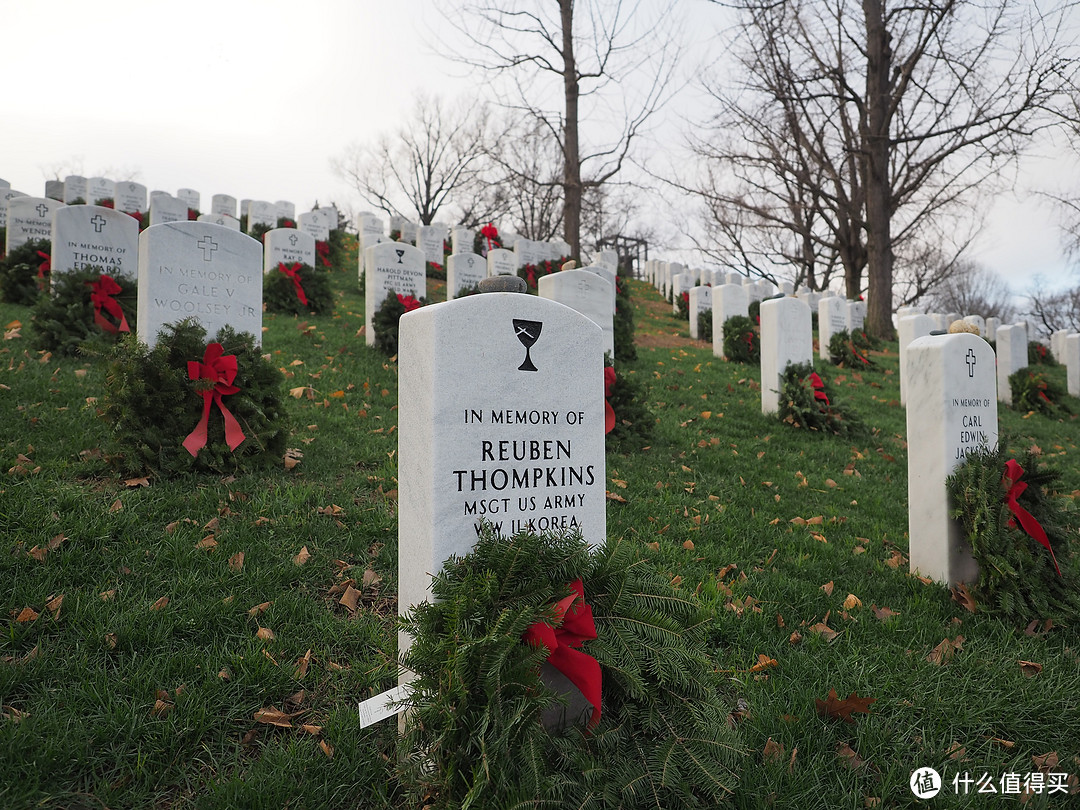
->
<box><xmin>136</xmin><ymin>220</ymin><xmax>262</xmax><ymax>347</ymax></box>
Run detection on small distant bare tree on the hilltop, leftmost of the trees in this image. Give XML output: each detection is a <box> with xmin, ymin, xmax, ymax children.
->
<box><xmin>332</xmin><ymin>95</ymin><xmax>487</xmax><ymax>225</ymax></box>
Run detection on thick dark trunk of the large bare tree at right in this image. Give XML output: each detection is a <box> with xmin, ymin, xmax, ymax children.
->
<box><xmin>862</xmin><ymin>0</ymin><xmax>893</xmax><ymax>339</ymax></box>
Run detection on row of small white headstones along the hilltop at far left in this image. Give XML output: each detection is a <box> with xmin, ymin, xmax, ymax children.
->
<box><xmin>0</xmin><ymin>175</ymin><xmax>338</xmax><ymax>251</ymax></box>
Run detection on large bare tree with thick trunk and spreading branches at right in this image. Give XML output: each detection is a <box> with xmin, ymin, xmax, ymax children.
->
<box><xmin>698</xmin><ymin>0</ymin><xmax>1076</xmax><ymax>336</ymax></box>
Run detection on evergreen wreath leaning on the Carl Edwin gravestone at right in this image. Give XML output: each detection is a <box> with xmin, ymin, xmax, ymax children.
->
<box><xmin>945</xmin><ymin>438</ymin><xmax>1080</xmax><ymax>624</ymax></box>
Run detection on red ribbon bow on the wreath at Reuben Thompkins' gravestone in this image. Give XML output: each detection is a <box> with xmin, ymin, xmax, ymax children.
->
<box><xmin>522</xmin><ymin>579</ymin><xmax>600</xmax><ymax>728</ymax></box>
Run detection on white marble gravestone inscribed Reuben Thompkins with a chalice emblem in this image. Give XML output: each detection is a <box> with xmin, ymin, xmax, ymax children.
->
<box><xmin>397</xmin><ymin>289</ymin><xmax>607</xmax><ymax>665</ymax></box>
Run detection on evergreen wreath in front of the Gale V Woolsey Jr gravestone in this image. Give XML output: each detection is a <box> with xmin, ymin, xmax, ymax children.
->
<box><xmin>102</xmin><ymin>319</ymin><xmax>288</xmax><ymax>476</ymax></box>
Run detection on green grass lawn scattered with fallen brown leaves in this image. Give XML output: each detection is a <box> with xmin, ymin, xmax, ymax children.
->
<box><xmin>0</xmin><ymin>252</ymin><xmax>1080</xmax><ymax>808</ymax></box>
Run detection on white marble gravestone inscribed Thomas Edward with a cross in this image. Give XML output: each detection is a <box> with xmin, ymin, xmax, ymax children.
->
<box><xmin>52</xmin><ymin>205</ymin><xmax>138</xmax><ymax>282</ymax></box>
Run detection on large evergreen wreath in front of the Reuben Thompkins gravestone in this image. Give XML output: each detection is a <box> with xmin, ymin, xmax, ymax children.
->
<box><xmin>400</xmin><ymin>526</ymin><xmax>742</xmax><ymax>809</ymax></box>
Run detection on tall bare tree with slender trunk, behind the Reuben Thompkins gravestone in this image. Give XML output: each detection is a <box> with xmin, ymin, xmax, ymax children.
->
<box><xmin>436</xmin><ymin>0</ymin><xmax>678</xmax><ymax>258</ymax></box>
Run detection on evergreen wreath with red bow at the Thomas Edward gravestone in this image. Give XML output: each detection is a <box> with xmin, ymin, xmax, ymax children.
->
<box><xmin>30</xmin><ymin>267</ymin><xmax>138</xmax><ymax>356</ymax></box>
